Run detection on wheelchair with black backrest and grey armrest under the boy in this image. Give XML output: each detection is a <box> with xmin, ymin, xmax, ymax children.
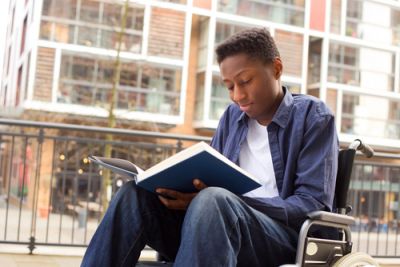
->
<box><xmin>136</xmin><ymin>139</ymin><xmax>379</xmax><ymax>267</ymax></box>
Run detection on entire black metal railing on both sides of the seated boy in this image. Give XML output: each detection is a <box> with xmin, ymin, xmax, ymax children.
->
<box><xmin>0</xmin><ymin>119</ymin><xmax>400</xmax><ymax>257</ymax></box>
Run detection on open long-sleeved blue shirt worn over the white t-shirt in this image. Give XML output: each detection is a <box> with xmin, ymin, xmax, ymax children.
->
<box><xmin>211</xmin><ymin>88</ymin><xmax>339</xmax><ymax>230</ymax></box>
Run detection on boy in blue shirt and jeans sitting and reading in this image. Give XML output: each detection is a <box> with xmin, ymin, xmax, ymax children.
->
<box><xmin>82</xmin><ymin>28</ymin><xmax>338</xmax><ymax>267</ymax></box>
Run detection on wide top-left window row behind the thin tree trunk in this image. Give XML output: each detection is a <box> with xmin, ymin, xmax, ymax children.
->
<box><xmin>40</xmin><ymin>0</ymin><xmax>144</xmax><ymax>53</ymax></box>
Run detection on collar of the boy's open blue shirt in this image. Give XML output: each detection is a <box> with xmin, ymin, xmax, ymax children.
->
<box><xmin>238</xmin><ymin>86</ymin><xmax>293</xmax><ymax>128</ymax></box>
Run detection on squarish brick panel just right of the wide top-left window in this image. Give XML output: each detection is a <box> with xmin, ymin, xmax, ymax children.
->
<box><xmin>148</xmin><ymin>8</ymin><xmax>185</xmax><ymax>59</ymax></box>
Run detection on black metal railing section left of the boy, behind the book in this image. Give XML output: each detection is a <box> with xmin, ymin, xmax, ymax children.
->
<box><xmin>0</xmin><ymin>119</ymin><xmax>210</xmax><ymax>252</ymax></box>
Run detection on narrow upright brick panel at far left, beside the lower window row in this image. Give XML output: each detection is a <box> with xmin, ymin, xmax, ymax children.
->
<box><xmin>33</xmin><ymin>47</ymin><xmax>55</xmax><ymax>102</ymax></box>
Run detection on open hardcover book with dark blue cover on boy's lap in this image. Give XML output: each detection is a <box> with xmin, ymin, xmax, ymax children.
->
<box><xmin>89</xmin><ymin>142</ymin><xmax>261</xmax><ymax>195</ymax></box>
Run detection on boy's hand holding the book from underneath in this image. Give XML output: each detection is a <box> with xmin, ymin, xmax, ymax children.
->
<box><xmin>156</xmin><ymin>179</ymin><xmax>207</xmax><ymax>210</ymax></box>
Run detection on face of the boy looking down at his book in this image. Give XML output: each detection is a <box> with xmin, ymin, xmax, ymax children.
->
<box><xmin>220</xmin><ymin>53</ymin><xmax>284</xmax><ymax>125</ymax></box>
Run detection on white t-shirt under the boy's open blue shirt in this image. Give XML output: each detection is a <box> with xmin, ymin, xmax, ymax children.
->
<box><xmin>239</xmin><ymin>119</ymin><xmax>279</xmax><ymax>197</ymax></box>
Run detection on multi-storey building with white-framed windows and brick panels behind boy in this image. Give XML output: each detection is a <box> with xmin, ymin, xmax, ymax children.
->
<box><xmin>0</xmin><ymin>0</ymin><xmax>400</xmax><ymax>247</ymax></box>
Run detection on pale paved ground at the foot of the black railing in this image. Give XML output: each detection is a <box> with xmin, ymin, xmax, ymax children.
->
<box><xmin>0</xmin><ymin>205</ymin><xmax>400</xmax><ymax>267</ymax></box>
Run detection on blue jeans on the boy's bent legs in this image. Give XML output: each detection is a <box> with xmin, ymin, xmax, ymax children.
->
<box><xmin>81</xmin><ymin>182</ymin><xmax>298</xmax><ymax>267</ymax></box>
